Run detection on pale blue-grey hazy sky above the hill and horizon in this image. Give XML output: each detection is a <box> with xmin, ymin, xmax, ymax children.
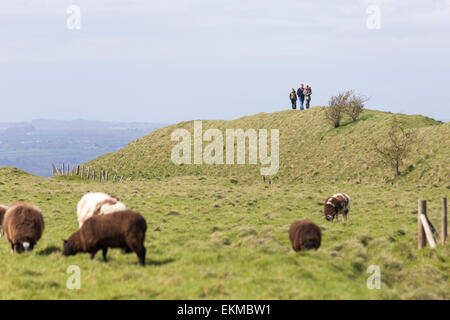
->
<box><xmin>0</xmin><ymin>0</ymin><xmax>450</xmax><ymax>123</ymax></box>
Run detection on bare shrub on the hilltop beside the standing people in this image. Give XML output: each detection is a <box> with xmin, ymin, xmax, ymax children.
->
<box><xmin>325</xmin><ymin>90</ymin><xmax>368</xmax><ymax>128</ymax></box>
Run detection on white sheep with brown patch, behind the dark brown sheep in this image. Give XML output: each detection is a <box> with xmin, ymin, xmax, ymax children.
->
<box><xmin>77</xmin><ymin>192</ymin><xmax>127</xmax><ymax>228</ymax></box>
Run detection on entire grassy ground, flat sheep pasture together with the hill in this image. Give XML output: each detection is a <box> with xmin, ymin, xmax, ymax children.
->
<box><xmin>0</xmin><ymin>108</ymin><xmax>450</xmax><ymax>299</ymax></box>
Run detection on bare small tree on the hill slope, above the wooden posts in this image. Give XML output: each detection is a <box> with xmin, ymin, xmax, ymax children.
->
<box><xmin>374</xmin><ymin>118</ymin><xmax>416</xmax><ymax>176</ymax></box>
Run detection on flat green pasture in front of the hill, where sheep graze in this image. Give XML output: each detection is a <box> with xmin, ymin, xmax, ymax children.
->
<box><xmin>0</xmin><ymin>169</ymin><xmax>450</xmax><ymax>299</ymax></box>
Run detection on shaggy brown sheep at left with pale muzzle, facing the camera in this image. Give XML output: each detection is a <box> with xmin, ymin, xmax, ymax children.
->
<box><xmin>3</xmin><ymin>202</ymin><xmax>44</xmax><ymax>253</ymax></box>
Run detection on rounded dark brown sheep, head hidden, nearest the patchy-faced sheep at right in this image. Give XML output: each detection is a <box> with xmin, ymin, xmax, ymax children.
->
<box><xmin>289</xmin><ymin>220</ymin><xmax>322</xmax><ymax>251</ymax></box>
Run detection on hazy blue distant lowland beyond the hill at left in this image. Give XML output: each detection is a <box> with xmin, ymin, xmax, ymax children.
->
<box><xmin>0</xmin><ymin>119</ymin><xmax>165</xmax><ymax>177</ymax></box>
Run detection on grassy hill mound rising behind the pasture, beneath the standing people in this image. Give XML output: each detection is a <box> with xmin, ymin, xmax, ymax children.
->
<box><xmin>87</xmin><ymin>107</ymin><xmax>450</xmax><ymax>185</ymax></box>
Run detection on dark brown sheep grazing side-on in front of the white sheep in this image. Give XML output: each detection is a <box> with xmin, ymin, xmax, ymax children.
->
<box><xmin>63</xmin><ymin>211</ymin><xmax>147</xmax><ymax>266</ymax></box>
